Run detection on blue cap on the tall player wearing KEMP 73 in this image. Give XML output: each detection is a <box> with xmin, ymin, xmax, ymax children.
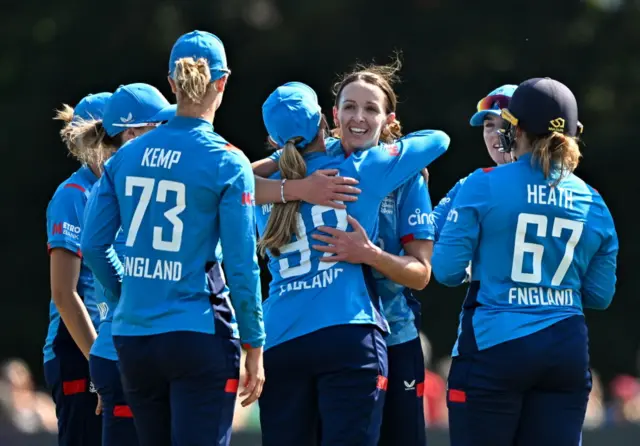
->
<box><xmin>169</xmin><ymin>30</ymin><xmax>230</xmax><ymax>82</ymax></box>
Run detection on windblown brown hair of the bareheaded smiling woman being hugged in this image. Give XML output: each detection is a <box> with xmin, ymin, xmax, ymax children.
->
<box><xmin>331</xmin><ymin>54</ymin><xmax>402</xmax><ymax>143</ymax></box>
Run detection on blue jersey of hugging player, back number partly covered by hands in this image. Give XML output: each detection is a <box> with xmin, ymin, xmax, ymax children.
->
<box><xmin>257</xmin><ymin>130</ymin><xmax>449</xmax><ymax>349</ymax></box>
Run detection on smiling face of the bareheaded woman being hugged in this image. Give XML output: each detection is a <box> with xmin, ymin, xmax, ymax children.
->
<box><xmin>333</xmin><ymin>80</ymin><xmax>395</xmax><ymax>153</ymax></box>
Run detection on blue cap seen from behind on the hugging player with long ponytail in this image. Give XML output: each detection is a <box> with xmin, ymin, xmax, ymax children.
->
<box><xmin>262</xmin><ymin>82</ymin><xmax>322</xmax><ymax>148</ymax></box>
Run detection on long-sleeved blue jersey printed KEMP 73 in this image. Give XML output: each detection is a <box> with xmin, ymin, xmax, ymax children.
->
<box><xmin>82</xmin><ymin>116</ymin><xmax>265</xmax><ymax>347</ymax></box>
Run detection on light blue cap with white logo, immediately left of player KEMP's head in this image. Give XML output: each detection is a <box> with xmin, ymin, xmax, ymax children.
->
<box><xmin>102</xmin><ymin>83</ymin><xmax>175</xmax><ymax>136</ymax></box>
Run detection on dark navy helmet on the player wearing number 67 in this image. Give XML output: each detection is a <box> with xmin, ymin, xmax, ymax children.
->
<box><xmin>502</xmin><ymin>77</ymin><xmax>582</xmax><ymax>136</ymax></box>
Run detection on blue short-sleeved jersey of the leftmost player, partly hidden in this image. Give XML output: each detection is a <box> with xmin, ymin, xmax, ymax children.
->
<box><xmin>43</xmin><ymin>166</ymin><xmax>99</xmax><ymax>362</ymax></box>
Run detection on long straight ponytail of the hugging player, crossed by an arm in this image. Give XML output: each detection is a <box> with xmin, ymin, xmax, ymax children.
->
<box><xmin>258</xmin><ymin>137</ymin><xmax>307</xmax><ymax>257</ymax></box>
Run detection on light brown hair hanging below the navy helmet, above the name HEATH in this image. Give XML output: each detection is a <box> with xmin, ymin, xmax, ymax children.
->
<box><xmin>531</xmin><ymin>132</ymin><xmax>582</xmax><ymax>184</ymax></box>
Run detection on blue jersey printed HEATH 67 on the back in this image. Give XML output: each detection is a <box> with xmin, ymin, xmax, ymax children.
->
<box><xmin>433</xmin><ymin>154</ymin><xmax>618</xmax><ymax>356</ymax></box>
